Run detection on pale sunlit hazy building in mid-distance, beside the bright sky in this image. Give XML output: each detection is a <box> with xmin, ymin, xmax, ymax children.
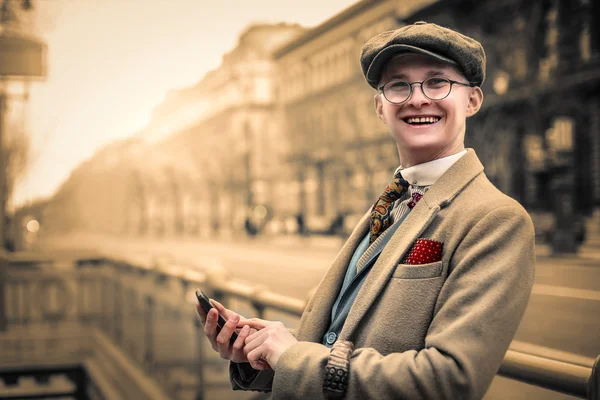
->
<box><xmin>143</xmin><ymin>24</ymin><xmax>303</xmax><ymax>234</ymax></box>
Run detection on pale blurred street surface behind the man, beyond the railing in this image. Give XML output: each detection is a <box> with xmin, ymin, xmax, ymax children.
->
<box><xmin>40</xmin><ymin>233</ymin><xmax>600</xmax><ymax>400</ymax></box>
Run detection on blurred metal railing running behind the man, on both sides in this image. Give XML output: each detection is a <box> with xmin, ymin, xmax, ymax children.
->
<box><xmin>0</xmin><ymin>252</ymin><xmax>600</xmax><ymax>400</ymax></box>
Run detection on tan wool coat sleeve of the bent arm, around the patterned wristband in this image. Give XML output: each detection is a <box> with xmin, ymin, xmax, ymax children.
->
<box><xmin>273</xmin><ymin>205</ymin><xmax>535</xmax><ymax>399</ymax></box>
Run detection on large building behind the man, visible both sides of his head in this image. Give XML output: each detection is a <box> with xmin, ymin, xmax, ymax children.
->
<box><xmin>276</xmin><ymin>0</ymin><xmax>600</xmax><ymax>251</ymax></box>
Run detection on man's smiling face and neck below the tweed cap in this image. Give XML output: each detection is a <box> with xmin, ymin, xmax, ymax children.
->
<box><xmin>375</xmin><ymin>54</ymin><xmax>483</xmax><ymax>167</ymax></box>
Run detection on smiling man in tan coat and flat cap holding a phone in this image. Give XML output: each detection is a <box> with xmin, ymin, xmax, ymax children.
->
<box><xmin>199</xmin><ymin>22</ymin><xmax>535</xmax><ymax>399</ymax></box>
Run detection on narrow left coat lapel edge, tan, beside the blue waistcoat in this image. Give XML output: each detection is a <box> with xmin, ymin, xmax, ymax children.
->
<box><xmin>298</xmin><ymin>210</ymin><xmax>371</xmax><ymax>342</ymax></box>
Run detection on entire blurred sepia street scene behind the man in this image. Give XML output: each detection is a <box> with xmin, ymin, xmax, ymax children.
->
<box><xmin>0</xmin><ymin>0</ymin><xmax>600</xmax><ymax>399</ymax></box>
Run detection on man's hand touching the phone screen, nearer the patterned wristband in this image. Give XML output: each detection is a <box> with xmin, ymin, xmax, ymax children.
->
<box><xmin>244</xmin><ymin>318</ymin><xmax>298</xmax><ymax>370</ymax></box>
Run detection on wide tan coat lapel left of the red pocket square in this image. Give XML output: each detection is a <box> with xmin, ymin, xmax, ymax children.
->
<box><xmin>340</xmin><ymin>149</ymin><xmax>483</xmax><ymax>340</ymax></box>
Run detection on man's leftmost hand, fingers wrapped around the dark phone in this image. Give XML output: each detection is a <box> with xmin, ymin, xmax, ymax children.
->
<box><xmin>196</xmin><ymin>299</ymin><xmax>254</xmax><ymax>363</ymax></box>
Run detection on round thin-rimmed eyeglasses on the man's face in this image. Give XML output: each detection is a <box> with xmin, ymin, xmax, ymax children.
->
<box><xmin>378</xmin><ymin>78</ymin><xmax>471</xmax><ymax>104</ymax></box>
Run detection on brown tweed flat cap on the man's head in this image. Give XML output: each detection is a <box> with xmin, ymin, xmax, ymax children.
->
<box><xmin>360</xmin><ymin>21</ymin><xmax>485</xmax><ymax>88</ymax></box>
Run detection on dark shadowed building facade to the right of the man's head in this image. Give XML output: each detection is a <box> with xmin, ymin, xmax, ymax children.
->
<box><xmin>426</xmin><ymin>0</ymin><xmax>600</xmax><ymax>252</ymax></box>
